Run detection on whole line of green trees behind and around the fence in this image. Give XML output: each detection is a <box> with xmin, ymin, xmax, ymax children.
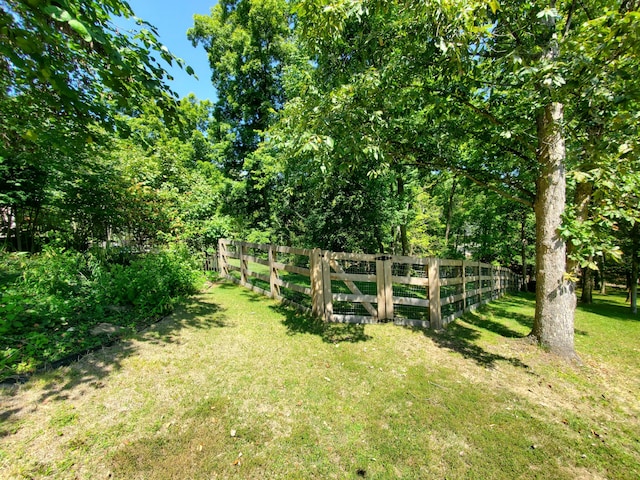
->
<box><xmin>0</xmin><ymin>0</ymin><xmax>640</xmax><ymax>357</ymax></box>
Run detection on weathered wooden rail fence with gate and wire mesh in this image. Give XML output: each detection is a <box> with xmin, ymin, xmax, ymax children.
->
<box><xmin>218</xmin><ymin>239</ymin><xmax>520</xmax><ymax>329</ymax></box>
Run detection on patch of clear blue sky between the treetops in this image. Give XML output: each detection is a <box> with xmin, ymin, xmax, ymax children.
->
<box><xmin>125</xmin><ymin>0</ymin><xmax>217</xmax><ymax>101</ymax></box>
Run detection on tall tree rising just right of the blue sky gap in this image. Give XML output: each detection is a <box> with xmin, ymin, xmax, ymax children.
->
<box><xmin>188</xmin><ymin>0</ymin><xmax>295</xmax><ymax>177</ymax></box>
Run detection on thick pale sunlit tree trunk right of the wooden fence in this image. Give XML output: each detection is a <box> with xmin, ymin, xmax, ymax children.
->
<box><xmin>531</xmin><ymin>102</ymin><xmax>576</xmax><ymax>358</ymax></box>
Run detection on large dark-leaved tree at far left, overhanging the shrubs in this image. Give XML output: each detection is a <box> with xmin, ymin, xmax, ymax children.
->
<box><xmin>0</xmin><ymin>0</ymin><xmax>191</xmax><ymax>249</ymax></box>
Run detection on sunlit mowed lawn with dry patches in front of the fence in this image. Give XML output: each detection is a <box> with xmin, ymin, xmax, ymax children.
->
<box><xmin>0</xmin><ymin>283</ymin><xmax>640</xmax><ymax>480</ymax></box>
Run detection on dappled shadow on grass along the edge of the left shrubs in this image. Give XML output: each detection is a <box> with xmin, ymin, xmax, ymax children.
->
<box><xmin>0</xmin><ymin>295</ymin><xmax>229</xmax><ymax>424</ymax></box>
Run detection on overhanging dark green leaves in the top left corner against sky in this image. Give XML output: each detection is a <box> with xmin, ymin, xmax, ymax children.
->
<box><xmin>0</xmin><ymin>0</ymin><xmax>181</xmax><ymax>128</ymax></box>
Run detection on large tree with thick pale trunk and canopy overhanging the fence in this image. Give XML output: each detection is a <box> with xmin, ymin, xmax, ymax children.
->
<box><xmin>294</xmin><ymin>0</ymin><xmax>638</xmax><ymax>357</ymax></box>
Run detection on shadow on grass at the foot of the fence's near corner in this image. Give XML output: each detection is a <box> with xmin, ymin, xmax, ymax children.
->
<box><xmin>271</xmin><ymin>304</ymin><xmax>371</xmax><ymax>343</ymax></box>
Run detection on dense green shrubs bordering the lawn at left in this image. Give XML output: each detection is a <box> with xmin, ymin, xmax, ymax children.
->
<box><xmin>0</xmin><ymin>246</ymin><xmax>201</xmax><ymax>380</ymax></box>
